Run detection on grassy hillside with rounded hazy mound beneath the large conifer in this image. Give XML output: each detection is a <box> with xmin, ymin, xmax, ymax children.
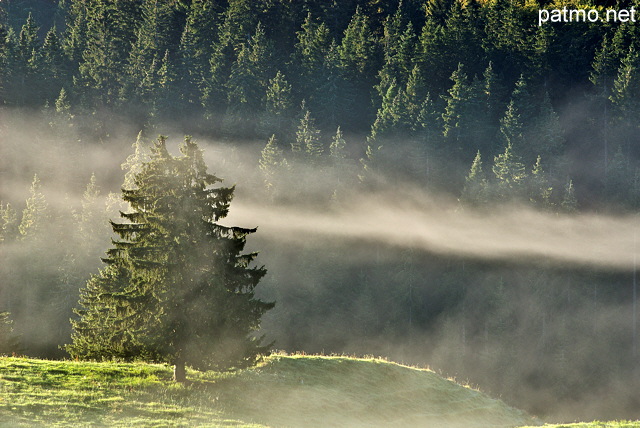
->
<box><xmin>0</xmin><ymin>356</ymin><xmax>532</xmax><ymax>428</ymax></box>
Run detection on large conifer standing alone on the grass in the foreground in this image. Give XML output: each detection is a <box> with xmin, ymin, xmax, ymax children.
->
<box><xmin>66</xmin><ymin>137</ymin><xmax>273</xmax><ymax>382</ymax></box>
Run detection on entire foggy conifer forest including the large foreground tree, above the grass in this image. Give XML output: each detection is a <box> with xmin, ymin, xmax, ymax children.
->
<box><xmin>0</xmin><ymin>0</ymin><xmax>640</xmax><ymax>420</ymax></box>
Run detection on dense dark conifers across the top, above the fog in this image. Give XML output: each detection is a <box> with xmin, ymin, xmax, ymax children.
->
<box><xmin>0</xmin><ymin>0</ymin><xmax>640</xmax><ymax>206</ymax></box>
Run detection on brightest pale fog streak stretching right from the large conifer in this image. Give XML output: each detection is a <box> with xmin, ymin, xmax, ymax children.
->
<box><xmin>225</xmin><ymin>191</ymin><xmax>638</xmax><ymax>270</ymax></box>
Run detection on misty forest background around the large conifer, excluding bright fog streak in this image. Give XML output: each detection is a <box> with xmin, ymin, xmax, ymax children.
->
<box><xmin>0</xmin><ymin>0</ymin><xmax>640</xmax><ymax>419</ymax></box>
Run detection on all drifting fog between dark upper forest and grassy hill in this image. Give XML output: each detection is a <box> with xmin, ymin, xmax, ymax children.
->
<box><xmin>0</xmin><ymin>108</ymin><xmax>640</xmax><ymax>421</ymax></box>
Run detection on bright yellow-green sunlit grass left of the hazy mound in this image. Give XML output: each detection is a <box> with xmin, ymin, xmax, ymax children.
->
<box><xmin>0</xmin><ymin>358</ymin><xmax>261</xmax><ymax>427</ymax></box>
